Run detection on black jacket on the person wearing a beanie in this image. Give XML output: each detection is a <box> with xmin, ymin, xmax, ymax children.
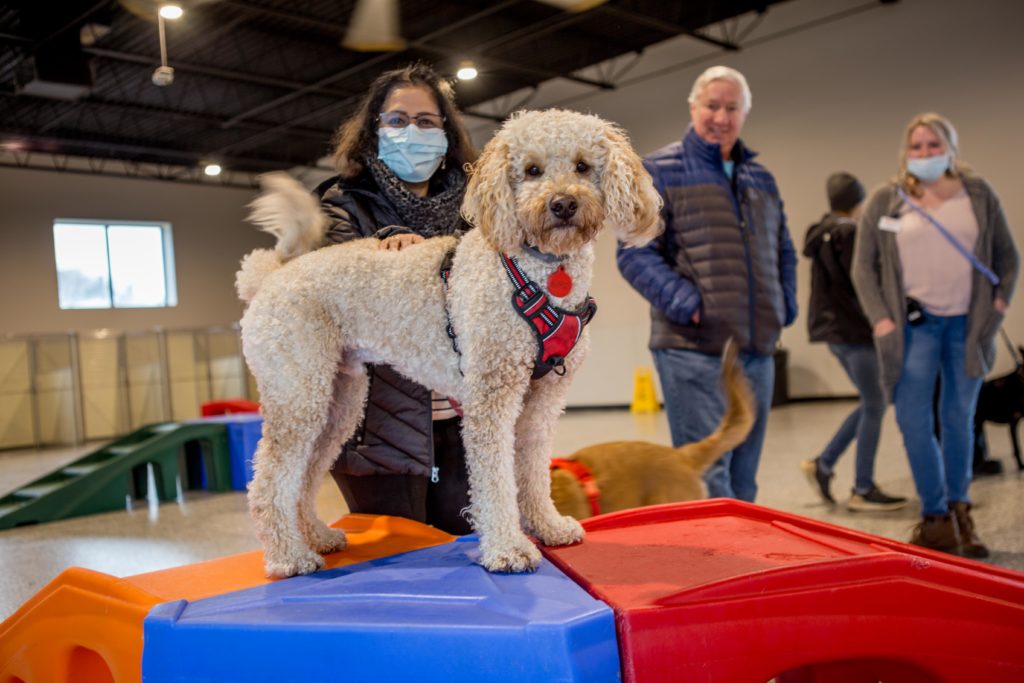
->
<box><xmin>804</xmin><ymin>213</ymin><xmax>873</xmax><ymax>345</ymax></box>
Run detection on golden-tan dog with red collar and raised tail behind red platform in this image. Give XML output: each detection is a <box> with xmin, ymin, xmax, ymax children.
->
<box><xmin>551</xmin><ymin>343</ymin><xmax>755</xmax><ymax>519</ymax></box>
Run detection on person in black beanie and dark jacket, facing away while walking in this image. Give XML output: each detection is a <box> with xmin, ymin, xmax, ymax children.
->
<box><xmin>800</xmin><ymin>172</ymin><xmax>906</xmax><ymax>511</ymax></box>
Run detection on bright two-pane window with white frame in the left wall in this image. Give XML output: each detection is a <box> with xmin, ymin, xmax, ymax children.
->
<box><xmin>53</xmin><ymin>220</ymin><xmax>177</xmax><ymax>309</ymax></box>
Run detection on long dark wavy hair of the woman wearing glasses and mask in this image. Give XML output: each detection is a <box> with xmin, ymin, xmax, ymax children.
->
<box><xmin>333</xmin><ymin>62</ymin><xmax>477</xmax><ymax>179</ymax></box>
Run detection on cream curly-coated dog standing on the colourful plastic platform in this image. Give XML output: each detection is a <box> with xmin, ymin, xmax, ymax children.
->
<box><xmin>237</xmin><ymin>110</ymin><xmax>660</xmax><ymax>577</ymax></box>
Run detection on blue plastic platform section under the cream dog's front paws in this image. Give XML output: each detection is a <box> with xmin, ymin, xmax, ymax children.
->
<box><xmin>142</xmin><ymin>536</ymin><xmax>620</xmax><ymax>683</ymax></box>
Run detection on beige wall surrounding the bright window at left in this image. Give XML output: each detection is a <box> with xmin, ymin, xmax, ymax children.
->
<box><xmin>0</xmin><ymin>168</ymin><xmax>272</xmax><ymax>334</ymax></box>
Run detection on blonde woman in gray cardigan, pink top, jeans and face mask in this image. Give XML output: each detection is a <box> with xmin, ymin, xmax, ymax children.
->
<box><xmin>853</xmin><ymin>114</ymin><xmax>1019</xmax><ymax>557</ymax></box>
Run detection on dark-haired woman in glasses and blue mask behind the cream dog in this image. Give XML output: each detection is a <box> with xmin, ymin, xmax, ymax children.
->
<box><xmin>316</xmin><ymin>65</ymin><xmax>476</xmax><ymax>535</ymax></box>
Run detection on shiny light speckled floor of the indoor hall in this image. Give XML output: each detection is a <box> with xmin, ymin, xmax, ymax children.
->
<box><xmin>0</xmin><ymin>401</ymin><xmax>1024</xmax><ymax>620</ymax></box>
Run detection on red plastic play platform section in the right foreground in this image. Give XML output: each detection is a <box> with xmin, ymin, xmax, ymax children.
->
<box><xmin>544</xmin><ymin>500</ymin><xmax>1024</xmax><ymax>683</ymax></box>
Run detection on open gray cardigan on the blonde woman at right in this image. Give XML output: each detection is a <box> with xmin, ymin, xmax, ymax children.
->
<box><xmin>852</xmin><ymin>176</ymin><xmax>1020</xmax><ymax>397</ymax></box>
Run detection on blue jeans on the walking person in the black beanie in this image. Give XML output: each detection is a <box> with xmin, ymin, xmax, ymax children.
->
<box><xmin>818</xmin><ymin>344</ymin><xmax>888</xmax><ymax>494</ymax></box>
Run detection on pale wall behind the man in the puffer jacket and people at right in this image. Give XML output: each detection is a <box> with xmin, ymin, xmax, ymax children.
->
<box><xmin>474</xmin><ymin>0</ymin><xmax>1024</xmax><ymax>404</ymax></box>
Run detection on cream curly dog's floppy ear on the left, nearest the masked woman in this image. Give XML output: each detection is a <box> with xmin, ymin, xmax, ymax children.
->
<box><xmin>462</xmin><ymin>131</ymin><xmax>521</xmax><ymax>251</ymax></box>
